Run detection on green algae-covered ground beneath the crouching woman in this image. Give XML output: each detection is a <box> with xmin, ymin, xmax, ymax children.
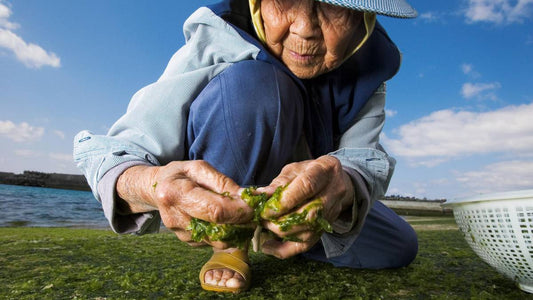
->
<box><xmin>0</xmin><ymin>217</ymin><xmax>533</xmax><ymax>299</ymax></box>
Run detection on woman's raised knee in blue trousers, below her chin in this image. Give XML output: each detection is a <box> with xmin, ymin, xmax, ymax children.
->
<box><xmin>187</xmin><ymin>60</ymin><xmax>303</xmax><ymax>185</ymax></box>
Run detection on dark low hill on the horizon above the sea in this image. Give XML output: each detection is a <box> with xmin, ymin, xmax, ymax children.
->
<box><xmin>0</xmin><ymin>171</ymin><xmax>90</xmax><ymax>191</ymax></box>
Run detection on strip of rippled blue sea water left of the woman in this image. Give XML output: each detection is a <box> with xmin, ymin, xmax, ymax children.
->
<box><xmin>0</xmin><ymin>184</ymin><xmax>109</xmax><ymax>228</ymax></box>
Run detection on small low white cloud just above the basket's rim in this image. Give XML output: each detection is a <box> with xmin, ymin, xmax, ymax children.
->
<box><xmin>457</xmin><ymin>160</ymin><xmax>533</xmax><ymax>193</ymax></box>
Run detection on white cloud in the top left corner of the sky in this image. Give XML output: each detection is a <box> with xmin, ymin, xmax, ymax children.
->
<box><xmin>0</xmin><ymin>1</ymin><xmax>61</xmax><ymax>68</ymax></box>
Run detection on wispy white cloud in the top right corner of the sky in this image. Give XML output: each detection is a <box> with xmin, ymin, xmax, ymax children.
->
<box><xmin>465</xmin><ymin>0</ymin><xmax>533</xmax><ymax>24</ymax></box>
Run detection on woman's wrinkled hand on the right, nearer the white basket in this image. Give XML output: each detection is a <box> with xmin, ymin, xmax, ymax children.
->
<box><xmin>258</xmin><ymin>155</ymin><xmax>354</xmax><ymax>259</ymax></box>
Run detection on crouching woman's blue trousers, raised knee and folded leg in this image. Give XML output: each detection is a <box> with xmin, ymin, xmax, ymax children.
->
<box><xmin>187</xmin><ymin>61</ymin><xmax>418</xmax><ymax>269</ymax></box>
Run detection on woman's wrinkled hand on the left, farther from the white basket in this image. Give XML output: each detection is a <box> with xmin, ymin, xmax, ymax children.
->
<box><xmin>117</xmin><ymin>161</ymin><xmax>253</xmax><ymax>248</ymax></box>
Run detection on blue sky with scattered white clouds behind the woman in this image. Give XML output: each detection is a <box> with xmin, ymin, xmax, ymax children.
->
<box><xmin>0</xmin><ymin>0</ymin><xmax>533</xmax><ymax>199</ymax></box>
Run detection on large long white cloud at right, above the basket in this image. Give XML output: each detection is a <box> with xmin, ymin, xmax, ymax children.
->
<box><xmin>382</xmin><ymin>103</ymin><xmax>533</xmax><ymax>166</ymax></box>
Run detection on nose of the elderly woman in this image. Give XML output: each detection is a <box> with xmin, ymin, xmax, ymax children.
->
<box><xmin>290</xmin><ymin>0</ymin><xmax>320</xmax><ymax>39</ymax></box>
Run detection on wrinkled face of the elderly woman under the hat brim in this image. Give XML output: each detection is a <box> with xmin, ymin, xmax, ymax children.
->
<box><xmin>261</xmin><ymin>0</ymin><xmax>364</xmax><ymax>79</ymax></box>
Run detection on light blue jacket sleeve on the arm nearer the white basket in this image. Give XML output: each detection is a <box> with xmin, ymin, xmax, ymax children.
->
<box><xmin>322</xmin><ymin>83</ymin><xmax>396</xmax><ymax>257</ymax></box>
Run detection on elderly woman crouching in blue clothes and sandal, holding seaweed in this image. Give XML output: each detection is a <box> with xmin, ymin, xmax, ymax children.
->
<box><xmin>74</xmin><ymin>0</ymin><xmax>417</xmax><ymax>292</ymax></box>
